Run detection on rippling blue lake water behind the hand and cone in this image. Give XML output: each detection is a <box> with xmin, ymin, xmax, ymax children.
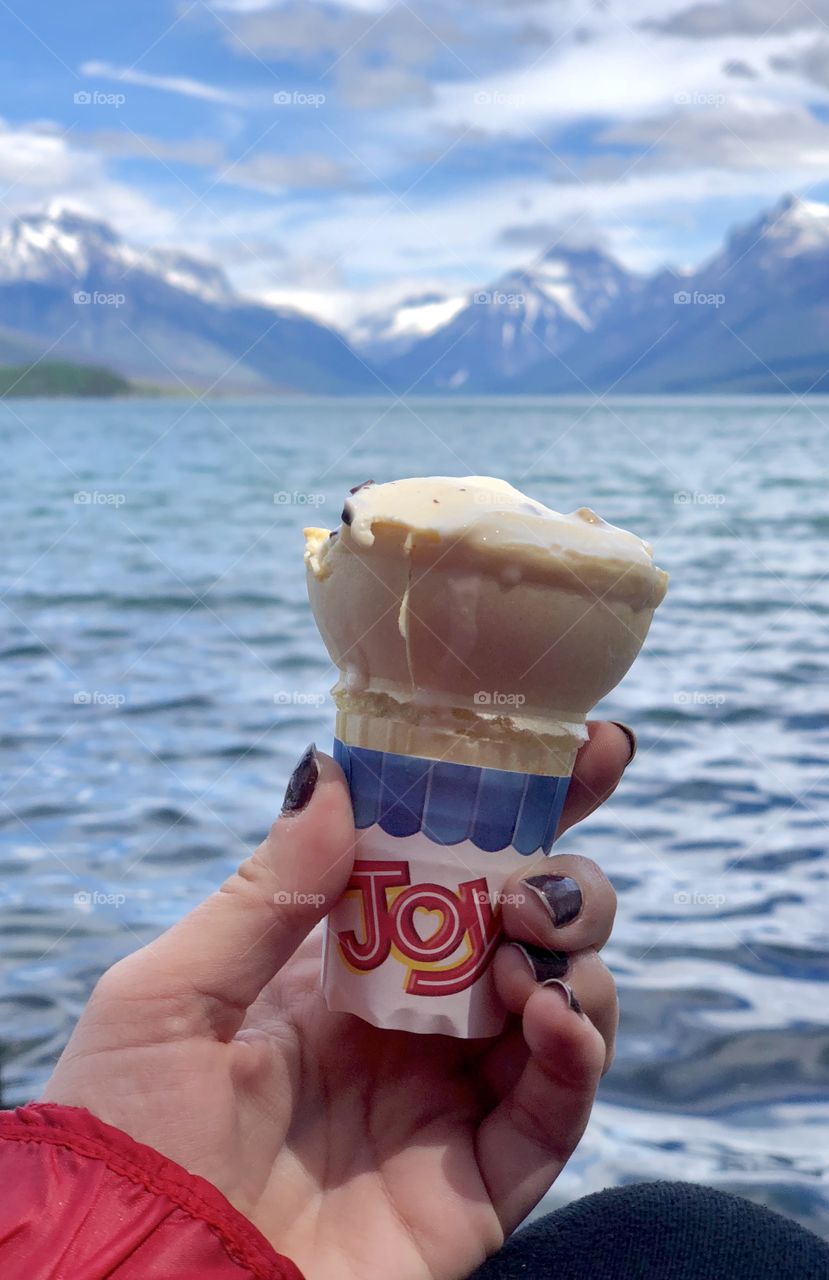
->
<box><xmin>0</xmin><ymin>399</ymin><xmax>829</xmax><ymax>1229</ymax></box>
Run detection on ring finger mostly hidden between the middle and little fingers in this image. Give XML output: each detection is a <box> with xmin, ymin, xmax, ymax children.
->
<box><xmin>494</xmin><ymin>943</ymin><xmax>619</xmax><ymax>1071</ymax></box>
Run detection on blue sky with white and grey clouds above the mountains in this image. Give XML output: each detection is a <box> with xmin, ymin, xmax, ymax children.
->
<box><xmin>0</xmin><ymin>0</ymin><xmax>829</xmax><ymax>328</ymax></box>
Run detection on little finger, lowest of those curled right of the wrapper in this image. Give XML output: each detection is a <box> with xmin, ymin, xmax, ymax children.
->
<box><xmin>476</xmin><ymin>986</ymin><xmax>605</xmax><ymax>1233</ymax></box>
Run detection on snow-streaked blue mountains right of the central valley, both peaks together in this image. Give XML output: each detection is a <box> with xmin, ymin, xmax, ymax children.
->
<box><xmin>375</xmin><ymin>196</ymin><xmax>829</xmax><ymax>394</ymax></box>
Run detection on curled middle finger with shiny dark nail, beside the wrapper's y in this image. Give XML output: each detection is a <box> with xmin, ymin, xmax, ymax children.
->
<box><xmin>501</xmin><ymin>854</ymin><xmax>617</xmax><ymax>951</ymax></box>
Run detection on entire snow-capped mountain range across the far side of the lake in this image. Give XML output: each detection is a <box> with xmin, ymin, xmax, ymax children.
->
<box><xmin>0</xmin><ymin>196</ymin><xmax>829</xmax><ymax>394</ymax></box>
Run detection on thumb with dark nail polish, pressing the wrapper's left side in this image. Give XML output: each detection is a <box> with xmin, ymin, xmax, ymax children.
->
<box><xmin>104</xmin><ymin>748</ymin><xmax>354</xmax><ymax>1039</ymax></box>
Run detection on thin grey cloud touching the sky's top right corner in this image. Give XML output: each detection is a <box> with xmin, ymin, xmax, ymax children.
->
<box><xmin>641</xmin><ymin>0</ymin><xmax>829</xmax><ymax>40</ymax></box>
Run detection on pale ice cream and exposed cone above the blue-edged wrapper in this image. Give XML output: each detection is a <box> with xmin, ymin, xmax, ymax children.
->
<box><xmin>306</xmin><ymin>476</ymin><xmax>668</xmax><ymax>774</ymax></box>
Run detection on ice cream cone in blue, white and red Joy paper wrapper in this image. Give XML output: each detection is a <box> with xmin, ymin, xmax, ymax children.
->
<box><xmin>306</xmin><ymin>476</ymin><xmax>667</xmax><ymax>1036</ymax></box>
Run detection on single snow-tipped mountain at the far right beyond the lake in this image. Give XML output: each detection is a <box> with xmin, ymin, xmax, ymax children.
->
<box><xmin>523</xmin><ymin>196</ymin><xmax>829</xmax><ymax>393</ymax></box>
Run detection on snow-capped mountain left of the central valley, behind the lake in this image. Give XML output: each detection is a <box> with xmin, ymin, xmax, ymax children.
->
<box><xmin>0</xmin><ymin>207</ymin><xmax>379</xmax><ymax>392</ymax></box>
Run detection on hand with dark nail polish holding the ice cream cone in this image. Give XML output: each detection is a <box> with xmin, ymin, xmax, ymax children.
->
<box><xmin>43</xmin><ymin>722</ymin><xmax>629</xmax><ymax>1280</ymax></box>
